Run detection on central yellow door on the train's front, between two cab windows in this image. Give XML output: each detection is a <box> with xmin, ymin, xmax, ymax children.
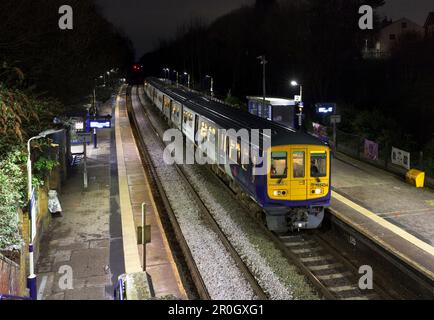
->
<box><xmin>290</xmin><ymin>148</ymin><xmax>308</xmax><ymax>201</ymax></box>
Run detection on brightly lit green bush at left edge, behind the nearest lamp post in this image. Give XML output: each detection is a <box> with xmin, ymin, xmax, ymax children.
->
<box><xmin>0</xmin><ymin>149</ymin><xmax>27</xmax><ymax>250</ymax></box>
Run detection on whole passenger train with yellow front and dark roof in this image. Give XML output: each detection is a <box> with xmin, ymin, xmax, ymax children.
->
<box><xmin>144</xmin><ymin>78</ymin><xmax>332</xmax><ymax>233</ymax></box>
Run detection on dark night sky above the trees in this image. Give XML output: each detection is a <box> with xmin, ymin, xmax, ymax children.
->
<box><xmin>97</xmin><ymin>0</ymin><xmax>434</xmax><ymax>57</ymax></box>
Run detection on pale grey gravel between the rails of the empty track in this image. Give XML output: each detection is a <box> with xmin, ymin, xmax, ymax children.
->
<box><xmin>132</xmin><ymin>89</ymin><xmax>257</xmax><ymax>300</ymax></box>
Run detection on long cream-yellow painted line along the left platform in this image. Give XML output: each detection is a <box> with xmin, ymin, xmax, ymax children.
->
<box><xmin>115</xmin><ymin>88</ymin><xmax>143</xmax><ymax>273</ymax></box>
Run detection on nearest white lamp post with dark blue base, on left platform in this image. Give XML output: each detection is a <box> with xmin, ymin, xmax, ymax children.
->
<box><xmin>27</xmin><ymin>129</ymin><xmax>63</xmax><ymax>300</ymax></box>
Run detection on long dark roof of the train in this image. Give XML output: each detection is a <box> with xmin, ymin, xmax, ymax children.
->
<box><xmin>147</xmin><ymin>78</ymin><xmax>327</xmax><ymax>146</ymax></box>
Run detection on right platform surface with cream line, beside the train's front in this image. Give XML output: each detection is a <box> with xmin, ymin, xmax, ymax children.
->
<box><xmin>331</xmin><ymin>154</ymin><xmax>434</xmax><ymax>279</ymax></box>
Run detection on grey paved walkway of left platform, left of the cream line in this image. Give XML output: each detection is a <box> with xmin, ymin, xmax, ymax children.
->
<box><xmin>36</xmin><ymin>92</ymin><xmax>125</xmax><ymax>300</ymax></box>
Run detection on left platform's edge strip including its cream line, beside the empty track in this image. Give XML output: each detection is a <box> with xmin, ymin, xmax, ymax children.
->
<box><xmin>115</xmin><ymin>87</ymin><xmax>187</xmax><ymax>299</ymax></box>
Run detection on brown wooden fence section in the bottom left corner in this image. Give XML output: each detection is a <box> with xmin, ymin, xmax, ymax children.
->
<box><xmin>0</xmin><ymin>254</ymin><xmax>21</xmax><ymax>295</ymax></box>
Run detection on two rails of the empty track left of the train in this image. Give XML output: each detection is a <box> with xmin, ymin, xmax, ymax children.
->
<box><xmin>129</xmin><ymin>85</ymin><xmax>268</xmax><ymax>300</ymax></box>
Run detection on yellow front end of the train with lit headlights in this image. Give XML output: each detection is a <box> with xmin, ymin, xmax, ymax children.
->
<box><xmin>257</xmin><ymin>141</ymin><xmax>331</xmax><ymax>232</ymax></box>
